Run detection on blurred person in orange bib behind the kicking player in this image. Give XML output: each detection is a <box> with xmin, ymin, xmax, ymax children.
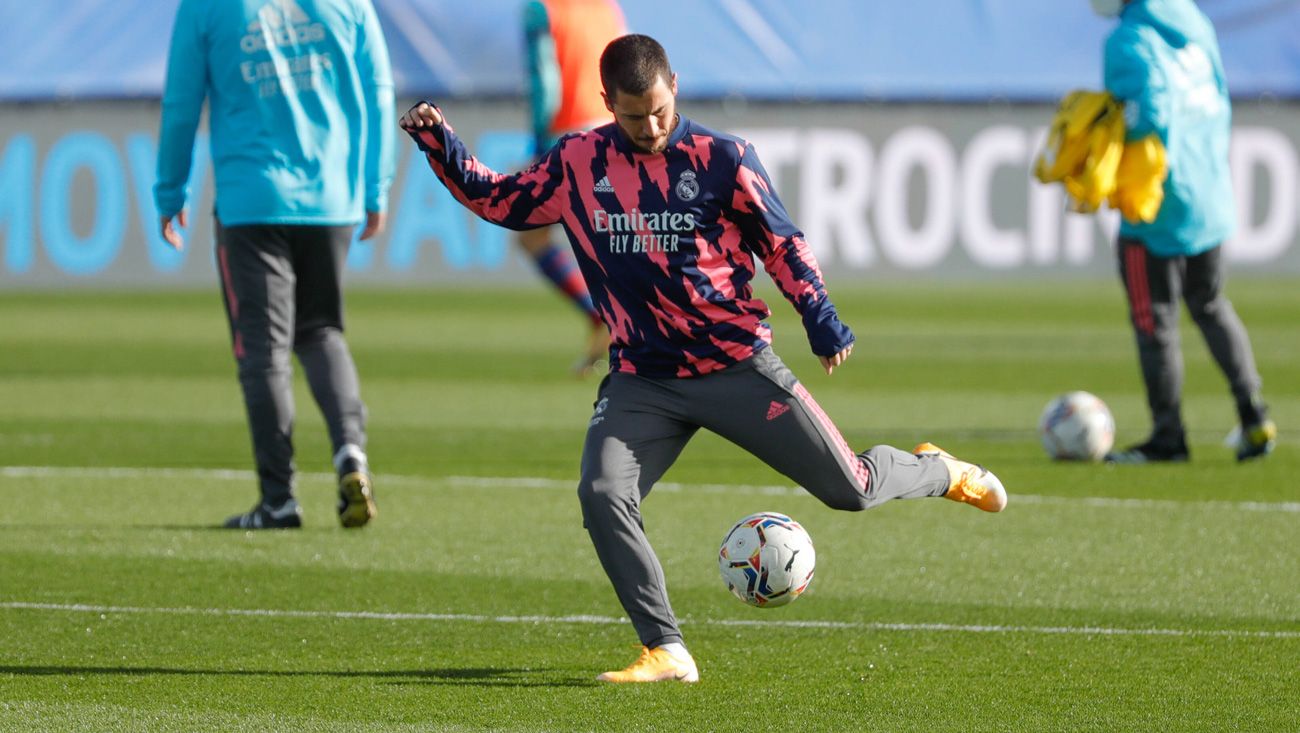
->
<box><xmin>516</xmin><ymin>0</ymin><xmax>628</xmax><ymax>376</ymax></box>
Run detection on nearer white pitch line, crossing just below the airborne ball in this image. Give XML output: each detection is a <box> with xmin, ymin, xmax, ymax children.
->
<box><xmin>0</xmin><ymin>600</ymin><xmax>1300</xmax><ymax>639</ymax></box>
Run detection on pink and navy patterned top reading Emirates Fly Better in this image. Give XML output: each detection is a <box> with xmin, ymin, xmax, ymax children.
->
<box><xmin>408</xmin><ymin>110</ymin><xmax>854</xmax><ymax>377</ymax></box>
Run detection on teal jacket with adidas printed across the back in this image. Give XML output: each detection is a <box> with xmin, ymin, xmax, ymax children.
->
<box><xmin>153</xmin><ymin>0</ymin><xmax>397</xmax><ymax>226</ymax></box>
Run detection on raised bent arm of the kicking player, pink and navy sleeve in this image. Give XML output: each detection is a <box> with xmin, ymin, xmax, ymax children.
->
<box><xmin>399</xmin><ymin>101</ymin><xmax>566</xmax><ymax>229</ymax></box>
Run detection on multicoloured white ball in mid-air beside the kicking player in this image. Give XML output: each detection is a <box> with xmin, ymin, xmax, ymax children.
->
<box><xmin>718</xmin><ymin>512</ymin><xmax>816</xmax><ymax>608</ymax></box>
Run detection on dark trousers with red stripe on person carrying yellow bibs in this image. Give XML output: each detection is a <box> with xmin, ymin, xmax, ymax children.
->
<box><xmin>1117</xmin><ymin>238</ymin><xmax>1264</xmax><ymax>448</ymax></box>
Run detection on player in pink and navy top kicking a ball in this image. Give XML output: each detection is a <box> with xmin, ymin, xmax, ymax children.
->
<box><xmin>400</xmin><ymin>35</ymin><xmax>1006</xmax><ymax>682</ymax></box>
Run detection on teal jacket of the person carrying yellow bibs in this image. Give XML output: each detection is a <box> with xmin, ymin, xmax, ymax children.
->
<box><xmin>1105</xmin><ymin>0</ymin><xmax>1236</xmax><ymax>257</ymax></box>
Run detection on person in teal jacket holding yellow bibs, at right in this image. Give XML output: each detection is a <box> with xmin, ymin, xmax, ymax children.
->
<box><xmin>1091</xmin><ymin>0</ymin><xmax>1277</xmax><ymax>463</ymax></box>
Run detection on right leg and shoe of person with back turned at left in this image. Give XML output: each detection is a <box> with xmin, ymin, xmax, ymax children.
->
<box><xmin>293</xmin><ymin>226</ymin><xmax>377</xmax><ymax>528</ymax></box>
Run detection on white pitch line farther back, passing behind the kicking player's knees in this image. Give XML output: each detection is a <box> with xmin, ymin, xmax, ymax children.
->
<box><xmin>0</xmin><ymin>465</ymin><xmax>1300</xmax><ymax>513</ymax></box>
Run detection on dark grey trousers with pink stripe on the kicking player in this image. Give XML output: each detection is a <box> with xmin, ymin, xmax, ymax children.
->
<box><xmin>577</xmin><ymin>348</ymin><xmax>948</xmax><ymax>647</ymax></box>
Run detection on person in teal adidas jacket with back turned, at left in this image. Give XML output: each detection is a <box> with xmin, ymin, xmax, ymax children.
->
<box><xmin>153</xmin><ymin>0</ymin><xmax>395</xmax><ymax>529</ymax></box>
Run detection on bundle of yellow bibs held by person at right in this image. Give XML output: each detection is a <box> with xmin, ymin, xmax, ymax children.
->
<box><xmin>1034</xmin><ymin>91</ymin><xmax>1167</xmax><ymax>222</ymax></box>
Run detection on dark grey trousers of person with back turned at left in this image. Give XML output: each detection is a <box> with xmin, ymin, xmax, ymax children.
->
<box><xmin>216</xmin><ymin>221</ymin><xmax>365</xmax><ymax>506</ymax></box>
